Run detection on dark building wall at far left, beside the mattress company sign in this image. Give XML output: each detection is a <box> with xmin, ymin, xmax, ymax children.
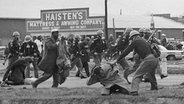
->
<box><xmin>0</xmin><ymin>18</ymin><xmax>26</xmax><ymax>45</ymax></box>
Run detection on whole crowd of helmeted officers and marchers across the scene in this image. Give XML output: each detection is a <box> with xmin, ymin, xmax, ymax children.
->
<box><xmin>1</xmin><ymin>28</ymin><xmax>181</xmax><ymax>95</ymax></box>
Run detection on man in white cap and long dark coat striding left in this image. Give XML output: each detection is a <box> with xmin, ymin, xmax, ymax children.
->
<box><xmin>32</xmin><ymin>29</ymin><xmax>59</xmax><ymax>88</ymax></box>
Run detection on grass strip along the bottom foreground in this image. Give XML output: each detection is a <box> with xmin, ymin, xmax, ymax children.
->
<box><xmin>0</xmin><ymin>84</ymin><xmax>184</xmax><ymax>104</ymax></box>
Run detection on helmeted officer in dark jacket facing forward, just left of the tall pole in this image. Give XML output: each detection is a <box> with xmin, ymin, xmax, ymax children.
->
<box><xmin>90</xmin><ymin>30</ymin><xmax>105</xmax><ymax>65</ymax></box>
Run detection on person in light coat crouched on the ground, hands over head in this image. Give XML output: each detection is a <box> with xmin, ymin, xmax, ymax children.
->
<box><xmin>87</xmin><ymin>63</ymin><xmax>129</xmax><ymax>95</ymax></box>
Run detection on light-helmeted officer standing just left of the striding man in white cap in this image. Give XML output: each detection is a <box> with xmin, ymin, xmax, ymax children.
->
<box><xmin>20</xmin><ymin>35</ymin><xmax>40</xmax><ymax>78</ymax></box>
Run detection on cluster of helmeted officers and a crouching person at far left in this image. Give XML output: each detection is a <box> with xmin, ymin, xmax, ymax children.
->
<box><xmin>3</xmin><ymin>31</ymin><xmax>43</xmax><ymax>85</ymax></box>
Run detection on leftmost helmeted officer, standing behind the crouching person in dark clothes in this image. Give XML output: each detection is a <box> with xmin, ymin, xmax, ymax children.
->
<box><xmin>8</xmin><ymin>31</ymin><xmax>21</xmax><ymax>66</ymax></box>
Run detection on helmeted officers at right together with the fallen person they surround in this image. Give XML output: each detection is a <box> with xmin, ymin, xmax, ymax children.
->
<box><xmin>88</xmin><ymin>28</ymin><xmax>167</xmax><ymax>96</ymax></box>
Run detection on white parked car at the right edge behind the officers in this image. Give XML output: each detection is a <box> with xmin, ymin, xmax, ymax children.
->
<box><xmin>159</xmin><ymin>45</ymin><xmax>184</xmax><ymax>60</ymax></box>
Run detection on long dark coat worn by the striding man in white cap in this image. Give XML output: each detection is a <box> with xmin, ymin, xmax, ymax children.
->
<box><xmin>38</xmin><ymin>37</ymin><xmax>58</xmax><ymax>74</ymax></box>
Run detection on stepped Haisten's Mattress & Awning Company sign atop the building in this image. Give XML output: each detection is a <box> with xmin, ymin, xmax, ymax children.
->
<box><xmin>26</xmin><ymin>8</ymin><xmax>104</xmax><ymax>32</ymax></box>
